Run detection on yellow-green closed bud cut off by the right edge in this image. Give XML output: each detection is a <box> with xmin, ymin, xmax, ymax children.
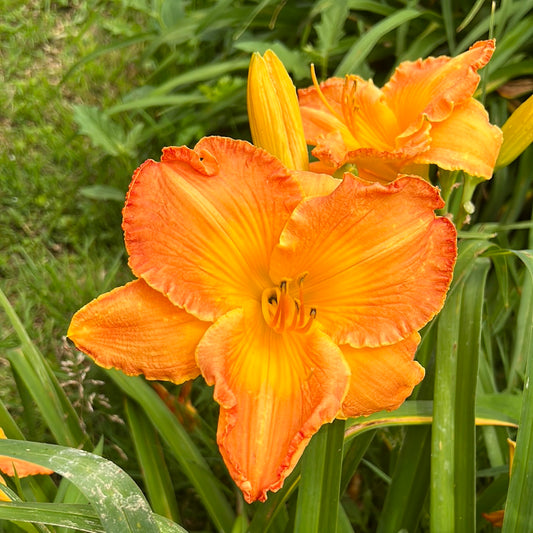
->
<box><xmin>496</xmin><ymin>95</ymin><xmax>533</xmax><ymax>168</ymax></box>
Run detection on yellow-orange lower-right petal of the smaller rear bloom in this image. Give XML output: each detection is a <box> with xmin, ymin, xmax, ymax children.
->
<box><xmin>415</xmin><ymin>98</ymin><xmax>503</xmax><ymax>179</ymax></box>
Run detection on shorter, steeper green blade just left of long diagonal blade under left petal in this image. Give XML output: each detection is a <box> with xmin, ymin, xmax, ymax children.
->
<box><xmin>126</xmin><ymin>401</ymin><xmax>180</xmax><ymax>522</ymax></box>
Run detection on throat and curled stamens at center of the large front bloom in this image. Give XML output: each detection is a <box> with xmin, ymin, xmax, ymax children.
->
<box><xmin>261</xmin><ymin>276</ymin><xmax>316</xmax><ymax>333</ymax></box>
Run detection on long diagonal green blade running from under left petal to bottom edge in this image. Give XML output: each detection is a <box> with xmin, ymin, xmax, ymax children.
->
<box><xmin>107</xmin><ymin>370</ymin><xmax>235</xmax><ymax>533</ymax></box>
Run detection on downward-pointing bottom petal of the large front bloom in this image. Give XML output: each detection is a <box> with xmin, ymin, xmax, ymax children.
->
<box><xmin>197</xmin><ymin>304</ymin><xmax>349</xmax><ymax>502</ymax></box>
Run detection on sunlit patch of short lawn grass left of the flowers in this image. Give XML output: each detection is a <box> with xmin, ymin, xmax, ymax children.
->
<box><xmin>0</xmin><ymin>1</ymin><xmax>135</xmax><ymax>356</ymax></box>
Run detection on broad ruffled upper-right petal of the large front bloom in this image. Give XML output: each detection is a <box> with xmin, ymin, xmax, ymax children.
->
<box><xmin>271</xmin><ymin>174</ymin><xmax>456</xmax><ymax>347</ymax></box>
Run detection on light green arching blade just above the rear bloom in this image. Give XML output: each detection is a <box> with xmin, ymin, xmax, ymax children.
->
<box><xmin>335</xmin><ymin>9</ymin><xmax>420</xmax><ymax>77</ymax></box>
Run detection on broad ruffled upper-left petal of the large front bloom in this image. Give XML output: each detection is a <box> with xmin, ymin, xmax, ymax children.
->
<box><xmin>123</xmin><ymin>137</ymin><xmax>301</xmax><ymax>320</ymax></box>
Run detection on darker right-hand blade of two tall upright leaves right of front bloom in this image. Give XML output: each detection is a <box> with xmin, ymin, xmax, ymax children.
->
<box><xmin>453</xmin><ymin>258</ymin><xmax>490</xmax><ymax>533</ymax></box>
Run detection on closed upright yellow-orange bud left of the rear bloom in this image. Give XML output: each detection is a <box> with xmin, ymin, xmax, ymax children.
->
<box><xmin>248</xmin><ymin>50</ymin><xmax>309</xmax><ymax>170</ymax></box>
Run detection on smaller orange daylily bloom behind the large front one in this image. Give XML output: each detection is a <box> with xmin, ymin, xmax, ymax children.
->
<box><xmin>299</xmin><ymin>40</ymin><xmax>502</xmax><ymax>181</ymax></box>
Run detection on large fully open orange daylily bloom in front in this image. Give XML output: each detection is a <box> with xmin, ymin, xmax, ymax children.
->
<box><xmin>68</xmin><ymin>137</ymin><xmax>456</xmax><ymax>502</ymax></box>
